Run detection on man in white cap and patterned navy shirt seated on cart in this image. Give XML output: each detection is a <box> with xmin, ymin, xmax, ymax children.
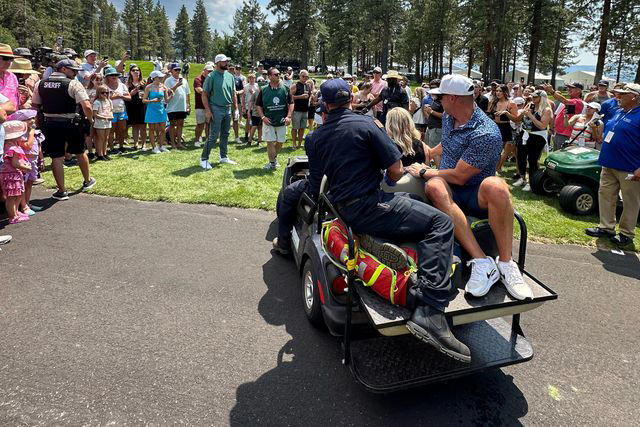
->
<box><xmin>409</xmin><ymin>74</ymin><xmax>533</xmax><ymax>300</ymax></box>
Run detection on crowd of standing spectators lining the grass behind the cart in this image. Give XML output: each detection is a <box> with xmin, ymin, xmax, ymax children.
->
<box><xmin>0</xmin><ymin>44</ymin><xmax>640</xmax><ymax>244</ymax></box>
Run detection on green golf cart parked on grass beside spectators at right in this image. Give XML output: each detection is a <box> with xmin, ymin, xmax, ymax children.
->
<box><xmin>530</xmin><ymin>147</ymin><xmax>601</xmax><ymax>215</ymax></box>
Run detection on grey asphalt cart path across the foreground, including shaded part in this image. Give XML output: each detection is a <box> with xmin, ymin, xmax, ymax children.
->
<box><xmin>0</xmin><ymin>190</ymin><xmax>640</xmax><ymax>425</ymax></box>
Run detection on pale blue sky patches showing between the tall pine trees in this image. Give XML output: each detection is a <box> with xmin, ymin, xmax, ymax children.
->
<box><xmin>112</xmin><ymin>0</ymin><xmax>596</xmax><ymax>65</ymax></box>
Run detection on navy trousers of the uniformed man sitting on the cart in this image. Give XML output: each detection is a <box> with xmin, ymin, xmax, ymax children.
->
<box><xmin>340</xmin><ymin>190</ymin><xmax>454</xmax><ymax>311</ymax></box>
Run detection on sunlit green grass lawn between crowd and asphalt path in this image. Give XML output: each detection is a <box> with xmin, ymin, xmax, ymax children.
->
<box><xmin>44</xmin><ymin>61</ymin><xmax>640</xmax><ymax>249</ymax></box>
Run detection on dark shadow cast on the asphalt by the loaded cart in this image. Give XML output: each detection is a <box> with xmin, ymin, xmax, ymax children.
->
<box><xmin>230</xmin><ymin>221</ymin><xmax>529</xmax><ymax>425</ymax></box>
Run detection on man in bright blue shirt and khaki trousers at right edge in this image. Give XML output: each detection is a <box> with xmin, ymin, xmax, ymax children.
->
<box><xmin>585</xmin><ymin>83</ymin><xmax>640</xmax><ymax>246</ymax></box>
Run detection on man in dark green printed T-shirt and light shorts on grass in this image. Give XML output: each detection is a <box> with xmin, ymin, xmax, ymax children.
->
<box><xmin>256</xmin><ymin>67</ymin><xmax>293</xmax><ymax>169</ymax></box>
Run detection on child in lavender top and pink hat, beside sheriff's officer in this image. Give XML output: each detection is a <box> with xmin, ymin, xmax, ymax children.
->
<box><xmin>9</xmin><ymin>110</ymin><xmax>44</xmax><ymax>216</ymax></box>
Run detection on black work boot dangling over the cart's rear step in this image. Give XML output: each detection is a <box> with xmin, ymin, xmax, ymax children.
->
<box><xmin>407</xmin><ymin>305</ymin><xmax>471</xmax><ymax>363</ymax></box>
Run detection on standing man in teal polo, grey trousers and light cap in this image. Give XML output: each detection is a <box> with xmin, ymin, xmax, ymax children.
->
<box><xmin>200</xmin><ymin>54</ymin><xmax>238</xmax><ymax>170</ymax></box>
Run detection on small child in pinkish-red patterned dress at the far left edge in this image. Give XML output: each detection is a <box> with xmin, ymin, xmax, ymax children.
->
<box><xmin>0</xmin><ymin>120</ymin><xmax>33</xmax><ymax>224</ymax></box>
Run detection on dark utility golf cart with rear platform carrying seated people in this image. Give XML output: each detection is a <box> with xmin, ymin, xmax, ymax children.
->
<box><xmin>283</xmin><ymin>157</ymin><xmax>557</xmax><ymax>393</ymax></box>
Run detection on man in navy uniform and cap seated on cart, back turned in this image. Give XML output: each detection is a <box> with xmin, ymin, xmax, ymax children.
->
<box><xmin>307</xmin><ymin>79</ymin><xmax>471</xmax><ymax>362</ymax></box>
